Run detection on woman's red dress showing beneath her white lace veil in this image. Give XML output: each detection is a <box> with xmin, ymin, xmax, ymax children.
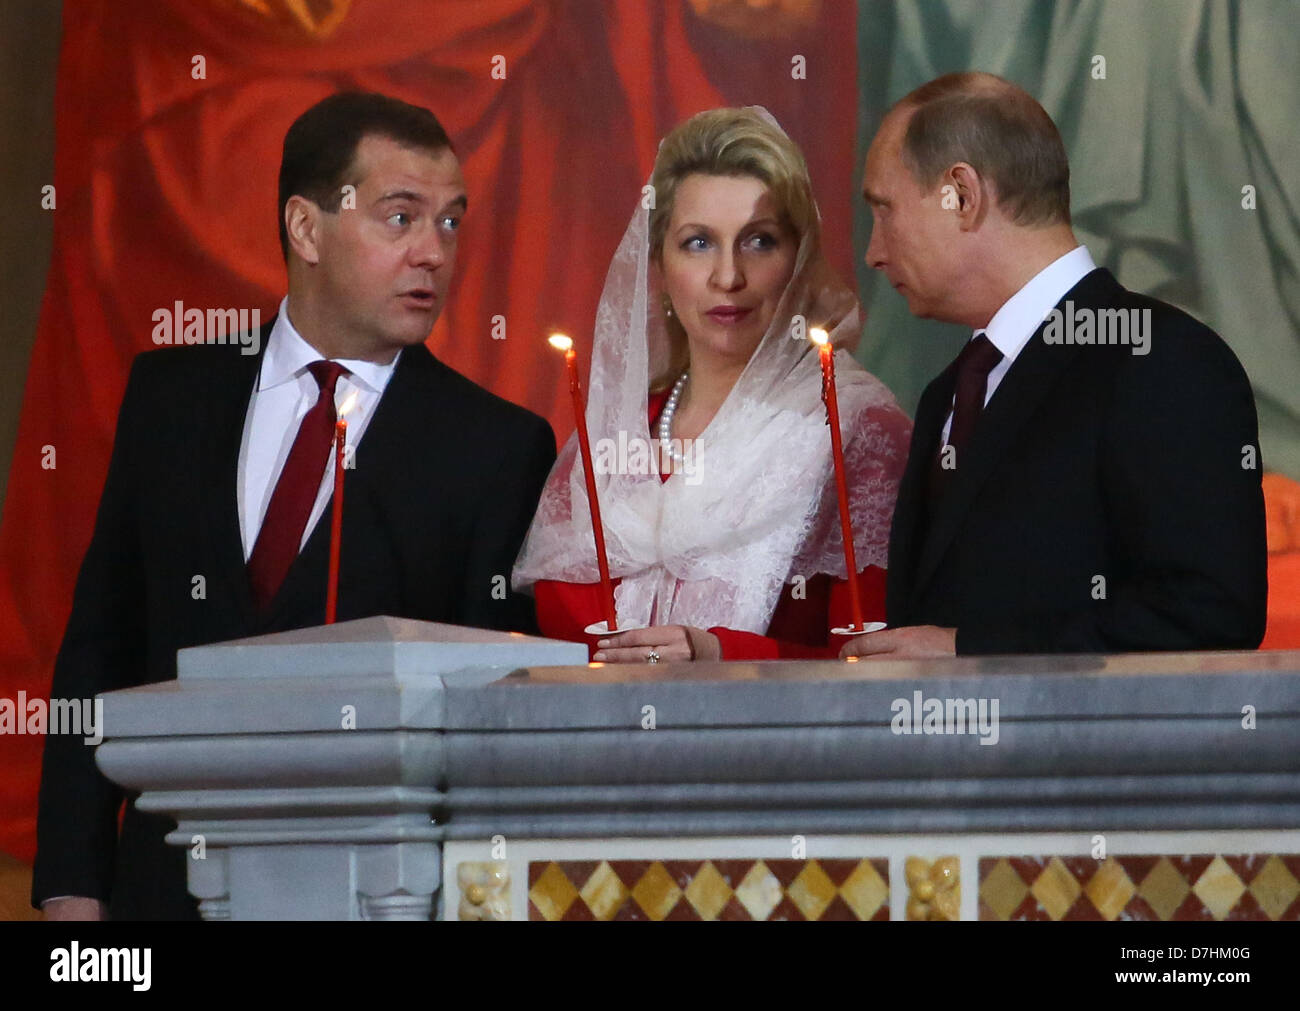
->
<box><xmin>533</xmin><ymin>392</ymin><xmax>885</xmax><ymax>660</ymax></box>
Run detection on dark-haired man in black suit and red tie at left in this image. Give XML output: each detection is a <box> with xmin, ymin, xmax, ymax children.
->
<box><xmin>33</xmin><ymin>94</ymin><xmax>555</xmax><ymax>919</ymax></box>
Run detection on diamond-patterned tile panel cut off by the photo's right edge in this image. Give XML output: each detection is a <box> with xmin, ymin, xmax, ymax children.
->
<box><xmin>979</xmin><ymin>854</ymin><xmax>1300</xmax><ymax>921</ymax></box>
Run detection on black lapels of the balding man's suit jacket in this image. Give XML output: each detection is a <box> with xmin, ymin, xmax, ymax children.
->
<box><xmin>907</xmin><ymin>269</ymin><xmax>1118</xmax><ymax>602</ymax></box>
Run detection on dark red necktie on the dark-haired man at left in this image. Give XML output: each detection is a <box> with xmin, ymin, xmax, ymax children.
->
<box><xmin>248</xmin><ymin>361</ymin><xmax>347</xmax><ymax>612</ymax></box>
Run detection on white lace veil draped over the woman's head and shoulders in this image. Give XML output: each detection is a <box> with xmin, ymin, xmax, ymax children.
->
<box><xmin>514</xmin><ymin>109</ymin><xmax>911</xmax><ymax>634</ymax></box>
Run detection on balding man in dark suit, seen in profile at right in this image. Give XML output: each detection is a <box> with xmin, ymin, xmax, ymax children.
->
<box><xmin>842</xmin><ymin>73</ymin><xmax>1268</xmax><ymax>659</ymax></box>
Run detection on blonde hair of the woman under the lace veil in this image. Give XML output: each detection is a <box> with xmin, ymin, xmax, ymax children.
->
<box><xmin>650</xmin><ymin>108</ymin><xmax>822</xmax><ymax>390</ymax></box>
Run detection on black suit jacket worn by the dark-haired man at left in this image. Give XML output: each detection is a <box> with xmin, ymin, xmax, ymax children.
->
<box><xmin>33</xmin><ymin>325</ymin><xmax>555</xmax><ymax>919</ymax></box>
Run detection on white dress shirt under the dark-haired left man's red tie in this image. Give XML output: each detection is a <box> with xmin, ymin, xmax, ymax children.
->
<box><xmin>239</xmin><ymin>295</ymin><xmax>402</xmax><ymax>561</ymax></box>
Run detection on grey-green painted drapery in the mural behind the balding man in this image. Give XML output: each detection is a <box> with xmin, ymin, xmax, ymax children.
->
<box><xmin>855</xmin><ymin>0</ymin><xmax>1300</xmax><ymax>478</ymax></box>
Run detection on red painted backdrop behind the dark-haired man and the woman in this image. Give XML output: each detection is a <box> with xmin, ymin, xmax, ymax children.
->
<box><xmin>0</xmin><ymin>0</ymin><xmax>858</xmax><ymax>860</ymax></box>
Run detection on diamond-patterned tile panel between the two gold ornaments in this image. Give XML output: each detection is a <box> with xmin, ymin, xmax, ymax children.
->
<box><xmin>528</xmin><ymin>859</ymin><xmax>889</xmax><ymax>920</ymax></box>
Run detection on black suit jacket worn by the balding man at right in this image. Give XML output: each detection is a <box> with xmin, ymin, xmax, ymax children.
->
<box><xmin>887</xmin><ymin>269</ymin><xmax>1268</xmax><ymax>654</ymax></box>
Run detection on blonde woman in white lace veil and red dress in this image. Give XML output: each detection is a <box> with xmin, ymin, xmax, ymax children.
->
<box><xmin>514</xmin><ymin>108</ymin><xmax>911</xmax><ymax>663</ymax></box>
